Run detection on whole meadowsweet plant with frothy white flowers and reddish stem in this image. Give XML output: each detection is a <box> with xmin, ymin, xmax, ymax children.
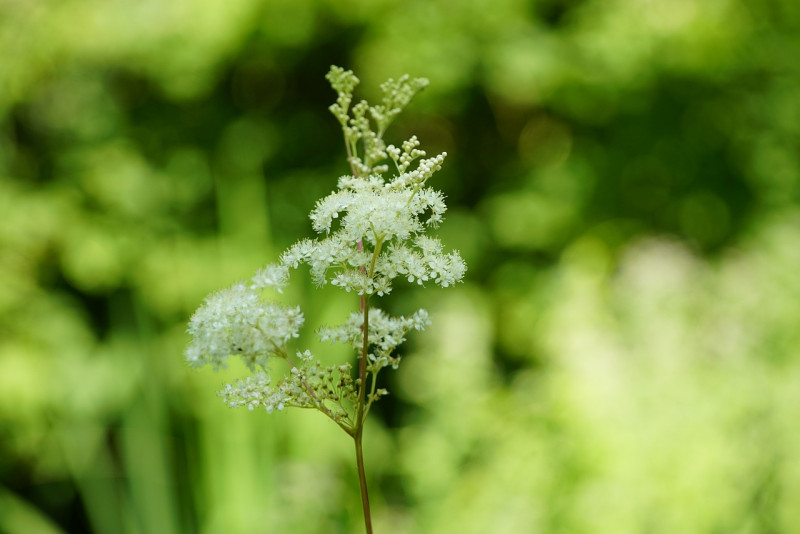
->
<box><xmin>185</xmin><ymin>67</ymin><xmax>466</xmax><ymax>532</ymax></box>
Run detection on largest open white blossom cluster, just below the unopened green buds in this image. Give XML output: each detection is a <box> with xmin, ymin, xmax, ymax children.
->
<box><xmin>281</xmin><ymin>149</ymin><xmax>466</xmax><ymax>296</ymax></box>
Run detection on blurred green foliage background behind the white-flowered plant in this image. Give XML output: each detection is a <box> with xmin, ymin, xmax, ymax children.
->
<box><xmin>0</xmin><ymin>0</ymin><xmax>800</xmax><ymax>534</ymax></box>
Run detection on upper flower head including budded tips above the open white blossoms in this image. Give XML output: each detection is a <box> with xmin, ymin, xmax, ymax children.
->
<box><xmin>281</xmin><ymin>67</ymin><xmax>466</xmax><ymax>296</ymax></box>
